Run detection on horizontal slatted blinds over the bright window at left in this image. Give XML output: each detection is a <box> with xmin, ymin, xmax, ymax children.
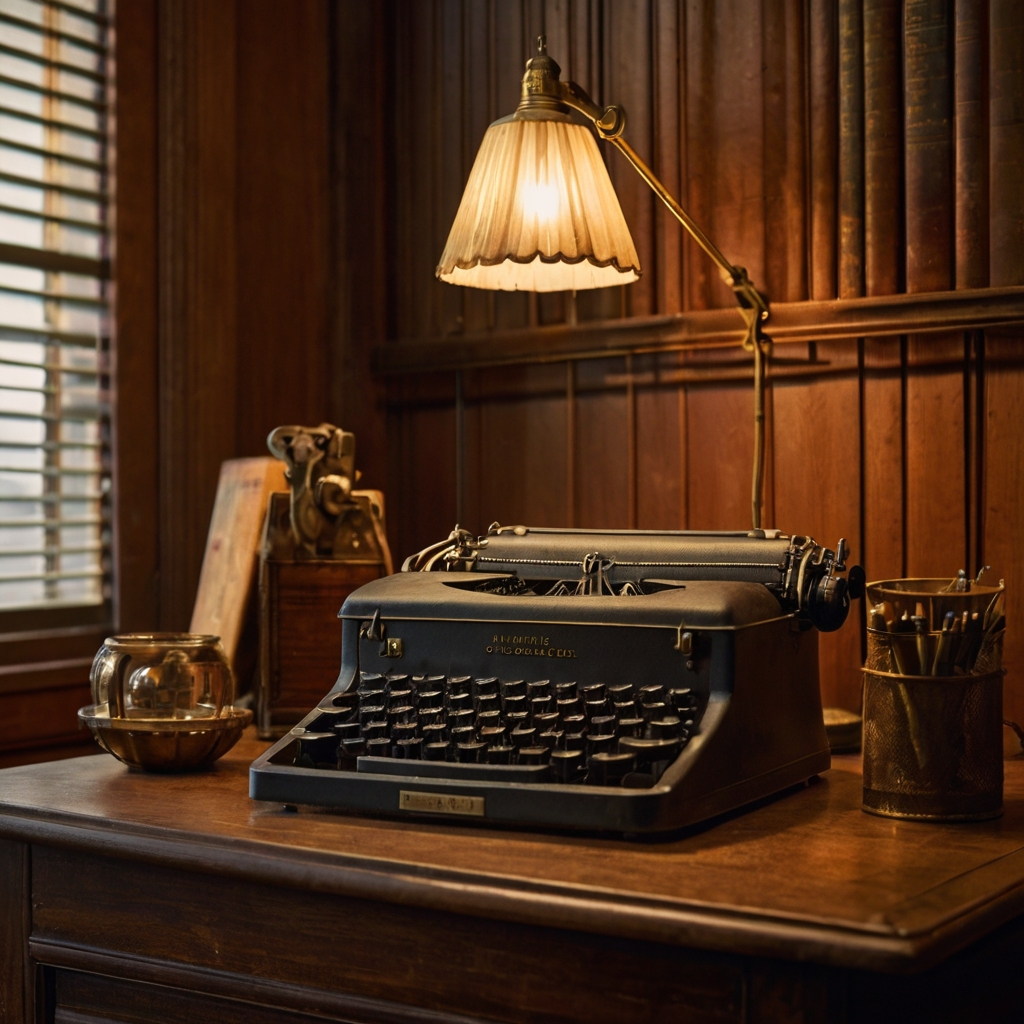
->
<box><xmin>0</xmin><ymin>0</ymin><xmax>111</xmax><ymax>610</ymax></box>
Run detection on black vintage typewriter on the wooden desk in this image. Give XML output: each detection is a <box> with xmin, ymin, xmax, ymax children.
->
<box><xmin>250</xmin><ymin>524</ymin><xmax>863</xmax><ymax>834</ymax></box>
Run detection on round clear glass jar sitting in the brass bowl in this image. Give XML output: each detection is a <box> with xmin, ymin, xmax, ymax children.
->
<box><xmin>89</xmin><ymin>633</ymin><xmax>234</xmax><ymax>723</ymax></box>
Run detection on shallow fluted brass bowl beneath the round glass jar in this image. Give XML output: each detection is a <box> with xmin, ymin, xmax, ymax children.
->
<box><xmin>78</xmin><ymin>703</ymin><xmax>253</xmax><ymax>772</ymax></box>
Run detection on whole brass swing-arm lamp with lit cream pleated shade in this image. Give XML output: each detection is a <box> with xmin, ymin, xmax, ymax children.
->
<box><xmin>436</xmin><ymin>36</ymin><xmax>771</xmax><ymax>529</ymax></box>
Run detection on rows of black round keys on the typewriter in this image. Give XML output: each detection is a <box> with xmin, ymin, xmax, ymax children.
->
<box><xmin>293</xmin><ymin>673</ymin><xmax>699</xmax><ymax>787</ymax></box>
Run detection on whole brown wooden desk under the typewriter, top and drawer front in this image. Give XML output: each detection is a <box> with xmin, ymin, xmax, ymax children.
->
<box><xmin>0</xmin><ymin>737</ymin><xmax>1024</xmax><ymax>1024</ymax></box>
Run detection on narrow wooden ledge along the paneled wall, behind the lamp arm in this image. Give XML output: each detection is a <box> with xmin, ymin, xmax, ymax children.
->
<box><xmin>373</xmin><ymin>287</ymin><xmax>1024</xmax><ymax>375</ymax></box>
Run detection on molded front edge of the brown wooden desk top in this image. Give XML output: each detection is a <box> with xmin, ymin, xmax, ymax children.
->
<box><xmin>0</xmin><ymin>805</ymin><xmax>1011</xmax><ymax>974</ymax></box>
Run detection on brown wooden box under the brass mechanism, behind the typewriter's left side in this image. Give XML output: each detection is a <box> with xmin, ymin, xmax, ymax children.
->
<box><xmin>256</xmin><ymin>492</ymin><xmax>390</xmax><ymax>739</ymax></box>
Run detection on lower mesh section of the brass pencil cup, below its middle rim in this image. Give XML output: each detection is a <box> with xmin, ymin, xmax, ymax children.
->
<box><xmin>863</xmin><ymin>668</ymin><xmax>1004</xmax><ymax>821</ymax></box>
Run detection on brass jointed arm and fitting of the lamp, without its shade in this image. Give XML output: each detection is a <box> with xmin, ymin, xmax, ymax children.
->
<box><xmin>513</xmin><ymin>36</ymin><xmax>771</xmax><ymax>529</ymax></box>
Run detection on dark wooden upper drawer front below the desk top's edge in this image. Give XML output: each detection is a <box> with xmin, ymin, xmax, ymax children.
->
<box><xmin>31</xmin><ymin>847</ymin><xmax>744</xmax><ymax>1024</ymax></box>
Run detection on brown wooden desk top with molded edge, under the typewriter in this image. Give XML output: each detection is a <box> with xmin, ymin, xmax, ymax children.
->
<box><xmin>0</xmin><ymin>734</ymin><xmax>1024</xmax><ymax>971</ymax></box>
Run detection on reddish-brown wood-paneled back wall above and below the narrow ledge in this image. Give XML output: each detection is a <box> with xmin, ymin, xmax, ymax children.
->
<box><xmin>380</xmin><ymin>0</ymin><xmax>1024</xmax><ymax>720</ymax></box>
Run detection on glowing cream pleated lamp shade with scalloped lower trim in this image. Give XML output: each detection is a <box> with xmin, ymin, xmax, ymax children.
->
<box><xmin>437</xmin><ymin>116</ymin><xmax>640</xmax><ymax>292</ymax></box>
